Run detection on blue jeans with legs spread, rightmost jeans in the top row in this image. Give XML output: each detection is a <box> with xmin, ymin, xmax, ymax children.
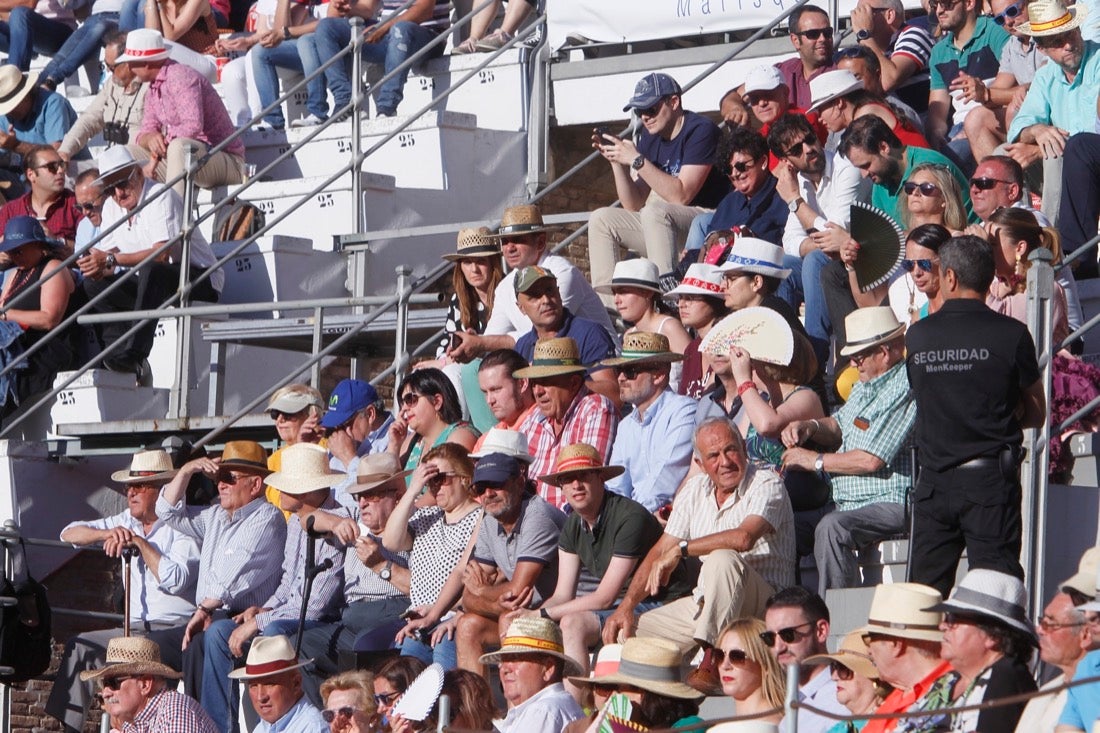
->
<box><xmin>315</xmin><ymin>18</ymin><xmax>443</xmax><ymax>116</ymax></box>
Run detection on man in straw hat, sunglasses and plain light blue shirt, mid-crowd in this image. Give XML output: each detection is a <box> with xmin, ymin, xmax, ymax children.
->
<box><xmin>600</xmin><ymin>331</ymin><xmax>699</xmax><ymax>512</ymax></box>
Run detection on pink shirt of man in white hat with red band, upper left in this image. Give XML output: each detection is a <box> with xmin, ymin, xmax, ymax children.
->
<box><xmin>141</xmin><ymin>59</ymin><xmax>244</xmax><ymax>157</ymax></box>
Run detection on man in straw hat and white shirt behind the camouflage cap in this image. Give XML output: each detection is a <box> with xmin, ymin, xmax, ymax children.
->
<box><xmin>448</xmin><ymin>204</ymin><xmax>615</xmax><ymax>361</ymax></box>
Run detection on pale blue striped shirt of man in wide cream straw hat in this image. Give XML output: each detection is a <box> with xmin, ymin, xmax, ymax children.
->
<box><xmin>256</xmin><ymin>495</ymin><xmax>344</xmax><ymax>632</ymax></box>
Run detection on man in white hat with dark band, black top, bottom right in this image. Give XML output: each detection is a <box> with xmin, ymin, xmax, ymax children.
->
<box><xmin>930</xmin><ymin>569</ymin><xmax>1037</xmax><ymax>731</ymax></box>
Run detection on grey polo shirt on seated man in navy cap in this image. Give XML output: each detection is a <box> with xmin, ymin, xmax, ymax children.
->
<box><xmin>473</xmin><ymin>494</ymin><xmax>565</xmax><ymax>605</ymax></box>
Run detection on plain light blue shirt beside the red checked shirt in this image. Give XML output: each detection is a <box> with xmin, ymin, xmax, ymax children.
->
<box><xmin>606</xmin><ymin>387</ymin><xmax>699</xmax><ymax>512</ymax></box>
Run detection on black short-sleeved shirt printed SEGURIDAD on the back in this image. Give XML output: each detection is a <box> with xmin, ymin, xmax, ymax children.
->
<box><xmin>905</xmin><ymin>298</ymin><xmax>1040</xmax><ymax>471</ymax></box>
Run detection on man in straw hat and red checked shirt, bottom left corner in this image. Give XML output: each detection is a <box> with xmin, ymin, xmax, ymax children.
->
<box><xmin>80</xmin><ymin>636</ymin><xmax>218</xmax><ymax>733</ymax></box>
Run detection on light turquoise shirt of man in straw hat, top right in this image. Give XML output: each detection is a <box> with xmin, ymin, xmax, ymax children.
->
<box><xmin>1008</xmin><ymin>41</ymin><xmax>1100</xmax><ymax>142</ymax></box>
